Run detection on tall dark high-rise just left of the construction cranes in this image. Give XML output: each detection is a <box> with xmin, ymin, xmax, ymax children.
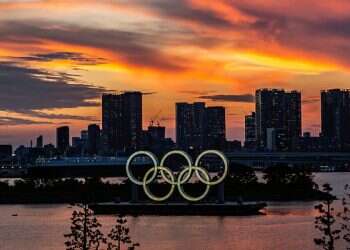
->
<box><xmin>102</xmin><ymin>92</ymin><xmax>142</xmax><ymax>153</ymax></box>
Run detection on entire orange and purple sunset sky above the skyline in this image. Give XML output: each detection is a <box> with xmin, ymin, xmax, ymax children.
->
<box><xmin>0</xmin><ymin>0</ymin><xmax>350</xmax><ymax>145</ymax></box>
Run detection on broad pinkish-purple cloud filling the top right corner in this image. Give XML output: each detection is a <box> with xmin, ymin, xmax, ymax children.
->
<box><xmin>231</xmin><ymin>0</ymin><xmax>350</xmax><ymax>65</ymax></box>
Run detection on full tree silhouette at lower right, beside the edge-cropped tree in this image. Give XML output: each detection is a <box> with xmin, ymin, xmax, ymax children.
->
<box><xmin>314</xmin><ymin>184</ymin><xmax>341</xmax><ymax>250</ymax></box>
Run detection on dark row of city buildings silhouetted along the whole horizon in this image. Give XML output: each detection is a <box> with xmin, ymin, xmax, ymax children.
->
<box><xmin>1</xmin><ymin>88</ymin><xmax>350</xmax><ymax>152</ymax></box>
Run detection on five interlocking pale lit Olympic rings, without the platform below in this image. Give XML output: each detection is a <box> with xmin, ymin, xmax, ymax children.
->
<box><xmin>126</xmin><ymin>150</ymin><xmax>228</xmax><ymax>202</ymax></box>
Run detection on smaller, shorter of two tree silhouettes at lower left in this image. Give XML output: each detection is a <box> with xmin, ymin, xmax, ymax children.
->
<box><xmin>107</xmin><ymin>215</ymin><xmax>140</xmax><ymax>250</ymax></box>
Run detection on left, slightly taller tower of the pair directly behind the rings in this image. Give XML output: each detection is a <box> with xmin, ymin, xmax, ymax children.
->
<box><xmin>176</xmin><ymin>102</ymin><xmax>206</xmax><ymax>150</ymax></box>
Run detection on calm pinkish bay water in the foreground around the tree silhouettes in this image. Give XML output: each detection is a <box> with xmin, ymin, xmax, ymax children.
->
<box><xmin>0</xmin><ymin>173</ymin><xmax>350</xmax><ymax>250</ymax></box>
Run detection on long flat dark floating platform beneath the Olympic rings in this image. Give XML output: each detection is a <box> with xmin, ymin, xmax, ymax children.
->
<box><xmin>90</xmin><ymin>202</ymin><xmax>267</xmax><ymax>216</ymax></box>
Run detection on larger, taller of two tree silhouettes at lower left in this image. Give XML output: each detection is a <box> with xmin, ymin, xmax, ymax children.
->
<box><xmin>64</xmin><ymin>204</ymin><xmax>106</xmax><ymax>250</ymax></box>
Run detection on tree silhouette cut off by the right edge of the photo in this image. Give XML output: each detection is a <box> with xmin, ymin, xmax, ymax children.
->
<box><xmin>339</xmin><ymin>185</ymin><xmax>350</xmax><ymax>250</ymax></box>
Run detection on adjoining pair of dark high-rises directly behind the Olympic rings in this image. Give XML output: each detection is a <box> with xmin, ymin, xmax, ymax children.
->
<box><xmin>176</xmin><ymin>102</ymin><xmax>226</xmax><ymax>150</ymax></box>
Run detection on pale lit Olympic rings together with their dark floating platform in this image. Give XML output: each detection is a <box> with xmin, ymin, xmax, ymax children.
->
<box><xmin>90</xmin><ymin>150</ymin><xmax>266</xmax><ymax>216</ymax></box>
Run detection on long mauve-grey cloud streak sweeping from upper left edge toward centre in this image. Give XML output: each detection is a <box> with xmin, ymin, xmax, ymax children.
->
<box><xmin>0</xmin><ymin>21</ymin><xmax>185</xmax><ymax>71</ymax></box>
